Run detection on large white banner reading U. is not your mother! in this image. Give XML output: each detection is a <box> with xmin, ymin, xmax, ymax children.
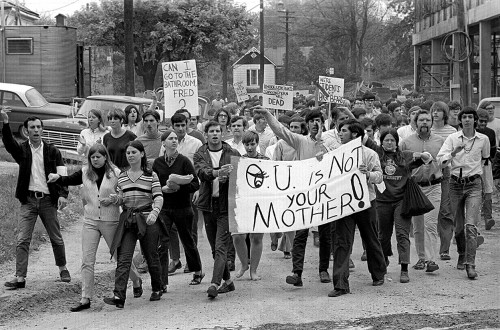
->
<box><xmin>228</xmin><ymin>139</ymin><xmax>370</xmax><ymax>233</ymax></box>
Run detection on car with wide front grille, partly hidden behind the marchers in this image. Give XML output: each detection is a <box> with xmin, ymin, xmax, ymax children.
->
<box><xmin>42</xmin><ymin>95</ymin><xmax>208</xmax><ymax>160</ymax></box>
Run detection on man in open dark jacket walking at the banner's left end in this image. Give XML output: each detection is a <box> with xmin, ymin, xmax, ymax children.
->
<box><xmin>193</xmin><ymin>121</ymin><xmax>240</xmax><ymax>298</ymax></box>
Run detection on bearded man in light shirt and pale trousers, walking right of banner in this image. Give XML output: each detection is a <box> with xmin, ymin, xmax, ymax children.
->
<box><xmin>400</xmin><ymin>110</ymin><xmax>444</xmax><ymax>272</ymax></box>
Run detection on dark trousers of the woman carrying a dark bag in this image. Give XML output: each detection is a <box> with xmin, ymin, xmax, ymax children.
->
<box><xmin>377</xmin><ymin>200</ymin><xmax>411</xmax><ymax>264</ymax></box>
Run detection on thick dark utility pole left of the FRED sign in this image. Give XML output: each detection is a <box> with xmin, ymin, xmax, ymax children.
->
<box><xmin>123</xmin><ymin>0</ymin><xmax>135</xmax><ymax>96</ymax></box>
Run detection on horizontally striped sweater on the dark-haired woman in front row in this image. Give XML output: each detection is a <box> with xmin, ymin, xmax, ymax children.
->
<box><xmin>117</xmin><ymin>171</ymin><xmax>163</xmax><ymax>216</ymax></box>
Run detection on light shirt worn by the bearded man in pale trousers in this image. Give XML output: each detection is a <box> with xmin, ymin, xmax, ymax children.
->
<box><xmin>400</xmin><ymin>133</ymin><xmax>444</xmax><ymax>182</ymax></box>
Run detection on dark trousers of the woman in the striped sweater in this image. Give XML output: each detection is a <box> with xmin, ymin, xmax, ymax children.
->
<box><xmin>113</xmin><ymin>220</ymin><xmax>162</xmax><ymax>300</ymax></box>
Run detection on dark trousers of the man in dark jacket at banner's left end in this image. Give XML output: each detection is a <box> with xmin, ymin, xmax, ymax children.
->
<box><xmin>203</xmin><ymin>198</ymin><xmax>232</xmax><ymax>285</ymax></box>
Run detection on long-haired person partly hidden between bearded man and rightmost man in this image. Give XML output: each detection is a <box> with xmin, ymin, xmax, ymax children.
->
<box><xmin>430</xmin><ymin>101</ymin><xmax>457</xmax><ymax>262</ymax></box>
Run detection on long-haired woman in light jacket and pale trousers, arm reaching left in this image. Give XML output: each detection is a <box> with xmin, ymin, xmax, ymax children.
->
<box><xmin>48</xmin><ymin>143</ymin><xmax>142</xmax><ymax>312</ymax></box>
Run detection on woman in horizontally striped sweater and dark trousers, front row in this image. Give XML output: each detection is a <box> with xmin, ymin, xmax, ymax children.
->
<box><xmin>104</xmin><ymin>141</ymin><xmax>163</xmax><ymax>308</ymax></box>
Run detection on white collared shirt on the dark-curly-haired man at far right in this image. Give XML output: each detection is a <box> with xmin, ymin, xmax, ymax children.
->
<box><xmin>437</xmin><ymin>131</ymin><xmax>490</xmax><ymax>177</ymax></box>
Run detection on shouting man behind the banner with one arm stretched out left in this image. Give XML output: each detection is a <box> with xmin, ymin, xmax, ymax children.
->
<box><xmin>254</xmin><ymin>106</ymin><xmax>331</xmax><ymax>286</ymax></box>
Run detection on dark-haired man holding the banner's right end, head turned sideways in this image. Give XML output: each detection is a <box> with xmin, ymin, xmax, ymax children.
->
<box><xmin>328</xmin><ymin>119</ymin><xmax>387</xmax><ymax>297</ymax></box>
